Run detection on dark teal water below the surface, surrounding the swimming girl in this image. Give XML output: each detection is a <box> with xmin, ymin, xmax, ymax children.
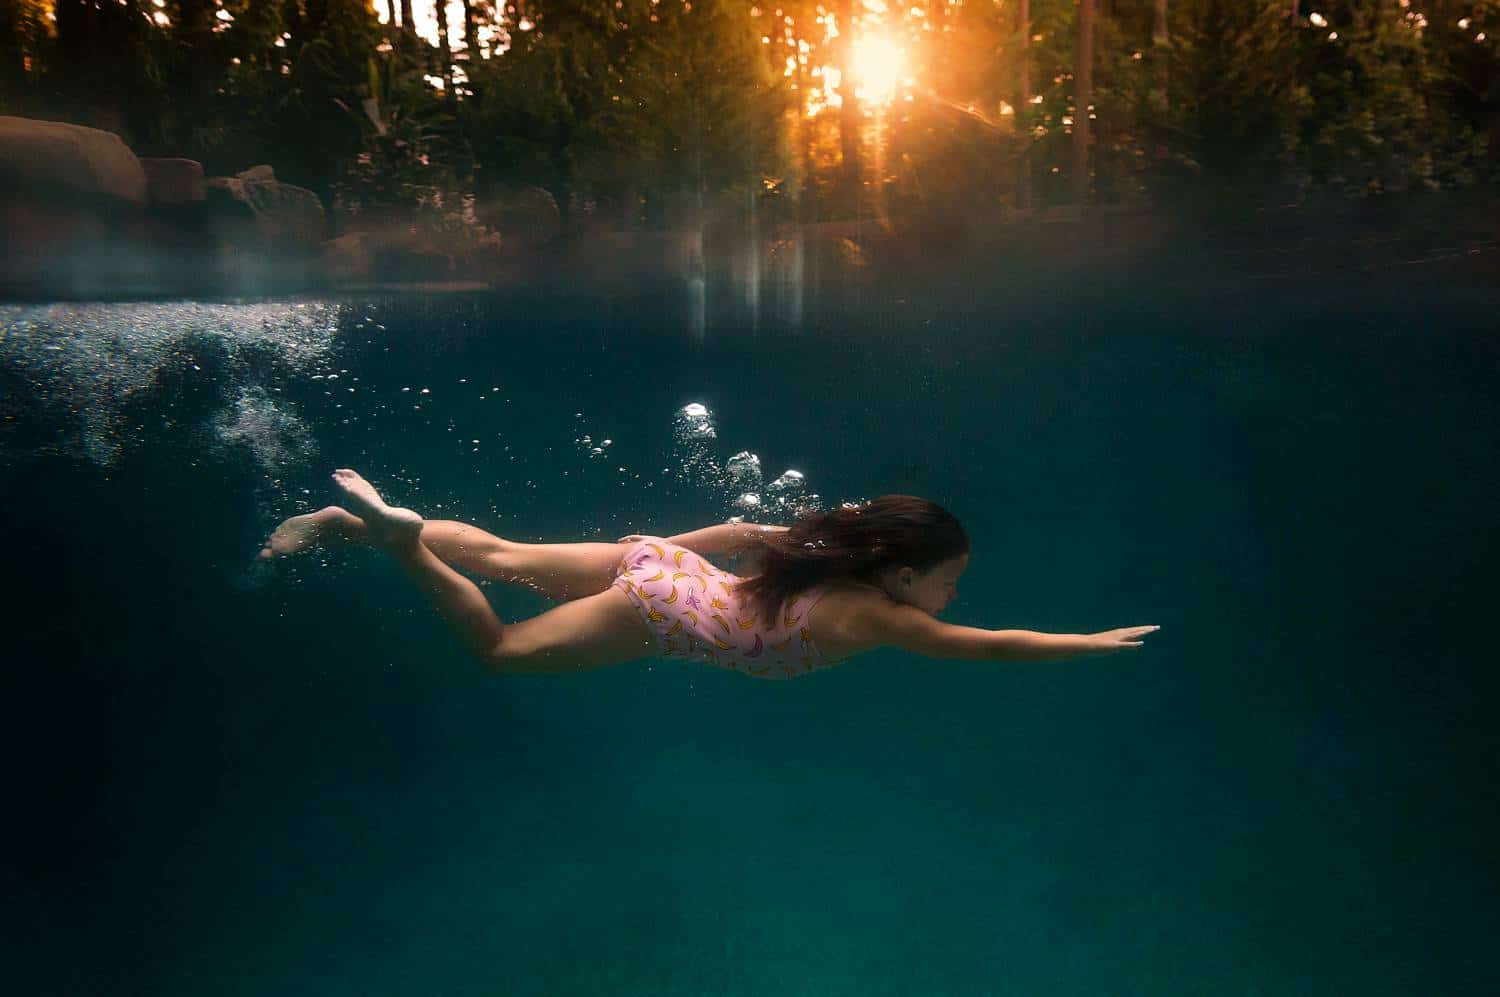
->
<box><xmin>0</xmin><ymin>269</ymin><xmax>1500</xmax><ymax>996</ymax></box>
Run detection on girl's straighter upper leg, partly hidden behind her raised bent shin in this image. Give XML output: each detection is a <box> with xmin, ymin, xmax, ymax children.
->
<box><xmin>260</xmin><ymin>505</ymin><xmax>624</xmax><ymax>600</ymax></box>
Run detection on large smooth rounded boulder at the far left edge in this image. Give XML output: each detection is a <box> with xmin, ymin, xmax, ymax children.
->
<box><xmin>0</xmin><ymin>115</ymin><xmax>147</xmax><ymax>205</ymax></box>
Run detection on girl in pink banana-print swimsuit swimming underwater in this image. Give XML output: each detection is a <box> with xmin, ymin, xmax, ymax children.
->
<box><xmin>261</xmin><ymin>469</ymin><xmax>1160</xmax><ymax>679</ymax></box>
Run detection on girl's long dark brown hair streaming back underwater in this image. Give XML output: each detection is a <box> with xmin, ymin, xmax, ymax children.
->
<box><xmin>735</xmin><ymin>495</ymin><xmax>969</xmax><ymax>616</ymax></box>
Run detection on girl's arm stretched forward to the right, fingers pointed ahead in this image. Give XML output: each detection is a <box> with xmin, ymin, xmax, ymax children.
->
<box><xmin>849</xmin><ymin>601</ymin><xmax>1161</xmax><ymax>661</ymax></box>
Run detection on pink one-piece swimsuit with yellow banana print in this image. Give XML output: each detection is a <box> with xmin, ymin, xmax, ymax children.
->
<box><xmin>614</xmin><ymin>537</ymin><xmax>839</xmax><ymax>679</ymax></box>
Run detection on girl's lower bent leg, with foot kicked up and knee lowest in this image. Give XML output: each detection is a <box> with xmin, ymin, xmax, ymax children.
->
<box><xmin>333</xmin><ymin>469</ymin><xmax>653</xmax><ymax>672</ymax></box>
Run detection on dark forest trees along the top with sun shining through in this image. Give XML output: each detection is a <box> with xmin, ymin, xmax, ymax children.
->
<box><xmin>0</xmin><ymin>0</ymin><xmax>1500</xmax><ymax>226</ymax></box>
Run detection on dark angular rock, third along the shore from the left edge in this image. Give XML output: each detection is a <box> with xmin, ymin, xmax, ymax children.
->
<box><xmin>204</xmin><ymin>166</ymin><xmax>324</xmax><ymax>252</ymax></box>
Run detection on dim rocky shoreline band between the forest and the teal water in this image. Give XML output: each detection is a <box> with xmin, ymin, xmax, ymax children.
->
<box><xmin>0</xmin><ymin>115</ymin><xmax>1500</xmax><ymax>300</ymax></box>
